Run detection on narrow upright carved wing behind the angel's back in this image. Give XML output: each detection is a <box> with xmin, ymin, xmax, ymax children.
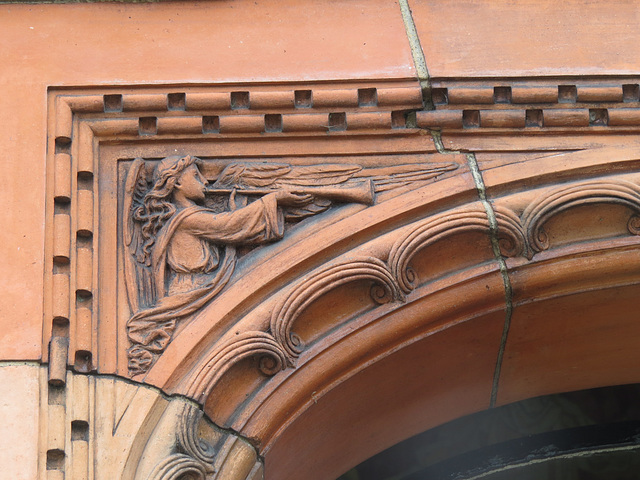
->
<box><xmin>122</xmin><ymin>158</ymin><xmax>154</xmax><ymax>313</ymax></box>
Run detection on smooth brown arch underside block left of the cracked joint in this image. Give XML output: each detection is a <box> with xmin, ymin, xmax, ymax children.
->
<box><xmin>266</xmin><ymin>312</ymin><xmax>503</xmax><ymax>479</ymax></box>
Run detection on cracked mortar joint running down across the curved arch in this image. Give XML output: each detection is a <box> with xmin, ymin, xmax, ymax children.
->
<box><xmin>467</xmin><ymin>154</ymin><xmax>513</xmax><ymax>408</ymax></box>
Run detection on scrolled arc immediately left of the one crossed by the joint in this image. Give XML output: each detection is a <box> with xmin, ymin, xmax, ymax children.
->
<box><xmin>271</xmin><ymin>257</ymin><xmax>404</xmax><ymax>358</ymax></box>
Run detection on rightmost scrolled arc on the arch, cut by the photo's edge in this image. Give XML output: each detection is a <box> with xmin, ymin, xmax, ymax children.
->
<box><xmin>522</xmin><ymin>180</ymin><xmax>640</xmax><ymax>253</ymax></box>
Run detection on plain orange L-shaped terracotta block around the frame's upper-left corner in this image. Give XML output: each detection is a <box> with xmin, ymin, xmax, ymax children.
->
<box><xmin>0</xmin><ymin>1</ymin><xmax>413</xmax><ymax>359</ymax></box>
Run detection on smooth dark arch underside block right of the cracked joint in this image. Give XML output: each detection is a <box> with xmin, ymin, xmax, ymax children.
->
<box><xmin>498</xmin><ymin>284</ymin><xmax>640</xmax><ymax>404</ymax></box>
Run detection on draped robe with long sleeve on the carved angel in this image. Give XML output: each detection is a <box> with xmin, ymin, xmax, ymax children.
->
<box><xmin>127</xmin><ymin>194</ymin><xmax>284</xmax><ymax>362</ymax></box>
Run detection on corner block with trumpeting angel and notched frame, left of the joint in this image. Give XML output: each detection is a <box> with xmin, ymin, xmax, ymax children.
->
<box><xmin>44</xmin><ymin>82</ymin><xmax>466</xmax><ymax>383</ymax></box>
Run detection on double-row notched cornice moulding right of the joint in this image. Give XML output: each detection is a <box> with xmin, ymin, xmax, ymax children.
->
<box><xmin>416</xmin><ymin>78</ymin><xmax>640</xmax><ymax>133</ymax></box>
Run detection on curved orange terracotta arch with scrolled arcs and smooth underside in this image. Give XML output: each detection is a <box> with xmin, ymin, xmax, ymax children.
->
<box><xmin>134</xmin><ymin>149</ymin><xmax>640</xmax><ymax>478</ymax></box>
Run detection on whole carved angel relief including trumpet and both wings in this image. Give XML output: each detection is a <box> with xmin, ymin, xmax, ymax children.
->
<box><xmin>122</xmin><ymin>155</ymin><xmax>458</xmax><ymax>376</ymax></box>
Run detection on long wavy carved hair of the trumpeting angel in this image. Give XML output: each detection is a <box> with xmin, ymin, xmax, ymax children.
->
<box><xmin>133</xmin><ymin>155</ymin><xmax>196</xmax><ymax>265</ymax></box>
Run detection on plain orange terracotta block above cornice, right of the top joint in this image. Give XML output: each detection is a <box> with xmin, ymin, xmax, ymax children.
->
<box><xmin>409</xmin><ymin>0</ymin><xmax>640</xmax><ymax>78</ymax></box>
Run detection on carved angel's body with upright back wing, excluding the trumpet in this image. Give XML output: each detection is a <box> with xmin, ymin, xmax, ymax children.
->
<box><xmin>124</xmin><ymin>156</ymin><xmax>312</xmax><ymax>375</ymax></box>
